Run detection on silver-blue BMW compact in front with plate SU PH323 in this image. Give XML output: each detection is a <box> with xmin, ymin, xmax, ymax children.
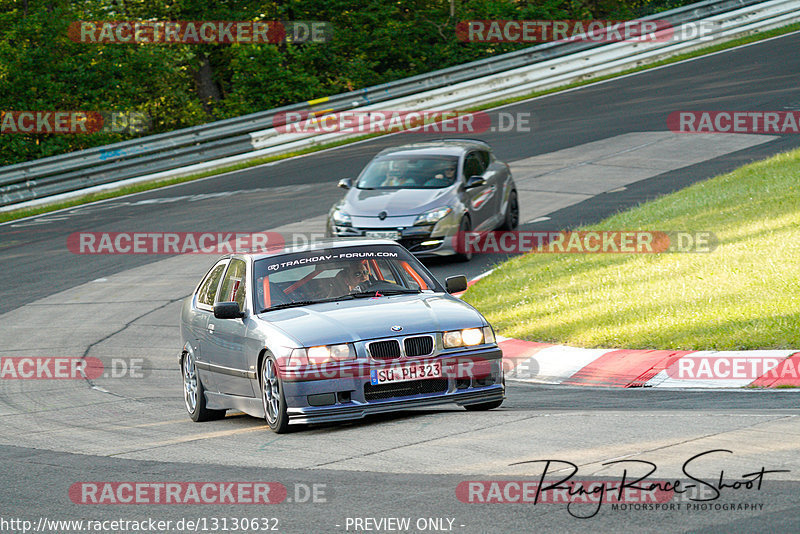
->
<box><xmin>179</xmin><ymin>239</ymin><xmax>505</xmax><ymax>432</ymax></box>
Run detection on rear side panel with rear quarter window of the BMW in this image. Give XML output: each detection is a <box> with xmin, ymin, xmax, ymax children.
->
<box><xmin>189</xmin><ymin>258</ymin><xmax>228</xmax><ymax>392</ymax></box>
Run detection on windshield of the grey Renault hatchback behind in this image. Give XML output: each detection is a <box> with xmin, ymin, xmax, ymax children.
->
<box><xmin>356</xmin><ymin>156</ymin><xmax>458</xmax><ymax>189</ymax></box>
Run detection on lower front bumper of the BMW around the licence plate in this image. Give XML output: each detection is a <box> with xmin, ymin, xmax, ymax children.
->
<box><xmin>283</xmin><ymin>346</ymin><xmax>505</xmax><ymax>423</ymax></box>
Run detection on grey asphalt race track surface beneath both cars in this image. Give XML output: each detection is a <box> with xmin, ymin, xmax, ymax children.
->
<box><xmin>0</xmin><ymin>33</ymin><xmax>800</xmax><ymax>533</ymax></box>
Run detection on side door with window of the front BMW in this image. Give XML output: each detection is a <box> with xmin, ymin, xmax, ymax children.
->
<box><xmin>207</xmin><ymin>258</ymin><xmax>254</xmax><ymax>397</ymax></box>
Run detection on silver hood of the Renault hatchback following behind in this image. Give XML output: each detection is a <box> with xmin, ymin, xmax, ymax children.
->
<box><xmin>342</xmin><ymin>187</ymin><xmax>452</xmax><ymax>217</ymax></box>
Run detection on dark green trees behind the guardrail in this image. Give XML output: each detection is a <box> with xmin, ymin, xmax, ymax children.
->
<box><xmin>0</xmin><ymin>0</ymin><xmax>691</xmax><ymax>165</ymax></box>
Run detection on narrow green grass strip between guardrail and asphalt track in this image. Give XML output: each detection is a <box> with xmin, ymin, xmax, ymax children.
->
<box><xmin>0</xmin><ymin>23</ymin><xmax>800</xmax><ymax>223</ymax></box>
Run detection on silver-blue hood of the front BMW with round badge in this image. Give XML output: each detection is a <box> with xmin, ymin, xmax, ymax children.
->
<box><xmin>258</xmin><ymin>294</ymin><xmax>487</xmax><ymax>347</ymax></box>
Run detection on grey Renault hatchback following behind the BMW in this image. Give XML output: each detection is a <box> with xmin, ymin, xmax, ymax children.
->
<box><xmin>326</xmin><ymin>139</ymin><xmax>519</xmax><ymax>260</ymax></box>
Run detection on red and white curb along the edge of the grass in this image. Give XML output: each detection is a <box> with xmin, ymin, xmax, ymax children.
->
<box><xmin>456</xmin><ymin>271</ymin><xmax>800</xmax><ymax>388</ymax></box>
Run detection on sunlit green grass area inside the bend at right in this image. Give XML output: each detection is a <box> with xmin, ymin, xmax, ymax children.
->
<box><xmin>465</xmin><ymin>150</ymin><xmax>800</xmax><ymax>350</ymax></box>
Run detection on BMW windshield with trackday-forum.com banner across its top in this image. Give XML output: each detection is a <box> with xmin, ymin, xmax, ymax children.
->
<box><xmin>253</xmin><ymin>245</ymin><xmax>442</xmax><ymax>311</ymax></box>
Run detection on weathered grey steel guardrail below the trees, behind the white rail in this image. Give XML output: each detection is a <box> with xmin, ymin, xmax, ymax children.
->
<box><xmin>0</xmin><ymin>0</ymin><xmax>785</xmax><ymax>208</ymax></box>
